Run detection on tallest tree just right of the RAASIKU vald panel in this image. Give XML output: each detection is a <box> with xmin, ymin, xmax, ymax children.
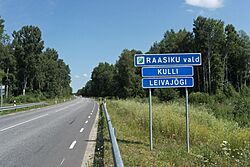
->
<box><xmin>193</xmin><ymin>16</ymin><xmax>225</xmax><ymax>94</ymax></box>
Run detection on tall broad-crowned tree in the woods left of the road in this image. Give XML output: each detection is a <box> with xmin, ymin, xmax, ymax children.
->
<box><xmin>12</xmin><ymin>26</ymin><xmax>44</xmax><ymax>95</ymax></box>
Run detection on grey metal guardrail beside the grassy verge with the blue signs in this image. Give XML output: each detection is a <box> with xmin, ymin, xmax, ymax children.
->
<box><xmin>102</xmin><ymin>103</ymin><xmax>124</xmax><ymax>167</ymax></box>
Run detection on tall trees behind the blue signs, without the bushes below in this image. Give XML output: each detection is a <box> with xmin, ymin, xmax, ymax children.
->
<box><xmin>78</xmin><ymin>16</ymin><xmax>250</xmax><ymax>98</ymax></box>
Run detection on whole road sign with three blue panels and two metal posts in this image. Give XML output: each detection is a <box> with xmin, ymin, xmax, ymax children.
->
<box><xmin>134</xmin><ymin>53</ymin><xmax>202</xmax><ymax>153</ymax></box>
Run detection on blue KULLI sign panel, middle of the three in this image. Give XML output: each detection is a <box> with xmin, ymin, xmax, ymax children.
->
<box><xmin>141</xmin><ymin>66</ymin><xmax>194</xmax><ymax>77</ymax></box>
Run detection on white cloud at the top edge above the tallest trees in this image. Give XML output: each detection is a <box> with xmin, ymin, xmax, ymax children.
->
<box><xmin>185</xmin><ymin>0</ymin><xmax>223</xmax><ymax>9</ymax></box>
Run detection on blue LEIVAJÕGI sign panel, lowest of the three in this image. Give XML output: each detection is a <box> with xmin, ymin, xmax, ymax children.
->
<box><xmin>142</xmin><ymin>77</ymin><xmax>194</xmax><ymax>88</ymax></box>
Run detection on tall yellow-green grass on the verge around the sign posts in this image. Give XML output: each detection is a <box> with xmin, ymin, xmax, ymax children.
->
<box><xmin>104</xmin><ymin>100</ymin><xmax>250</xmax><ymax>166</ymax></box>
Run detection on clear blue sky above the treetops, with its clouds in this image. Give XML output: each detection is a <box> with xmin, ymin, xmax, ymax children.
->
<box><xmin>0</xmin><ymin>0</ymin><xmax>250</xmax><ymax>92</ymax></box>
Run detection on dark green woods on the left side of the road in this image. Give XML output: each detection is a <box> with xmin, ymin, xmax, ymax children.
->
<box><xmin>0</xmin><ymin>17</ymin><xmax>72</xmax><ymax>102</ymax></box>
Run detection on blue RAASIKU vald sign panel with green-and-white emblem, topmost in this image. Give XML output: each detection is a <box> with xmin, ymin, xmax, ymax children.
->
<box><xmin>134</xmin><ymin>53</ymin><xmax>201</xmax><ymax>67</ymax></box>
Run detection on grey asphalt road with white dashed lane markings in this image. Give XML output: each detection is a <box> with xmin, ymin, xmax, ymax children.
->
<box><xmin>0</xmin><ymin>98</ymin><xmax>98</xmax><ymax>167</ymax></box>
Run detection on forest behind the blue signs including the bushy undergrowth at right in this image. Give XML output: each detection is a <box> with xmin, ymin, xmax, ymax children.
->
<box><xmin>77</xmin><ymin>16</ymin><xmax>250</xmax><ymax>127</ymax></box>
